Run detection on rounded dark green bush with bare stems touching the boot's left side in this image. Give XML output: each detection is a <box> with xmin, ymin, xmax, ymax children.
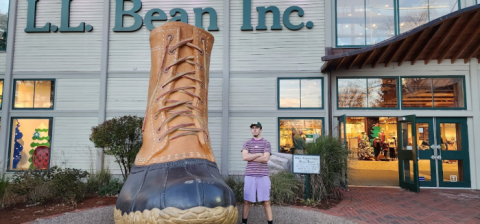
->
<box><xmin>90</xmin><ymin>116</ymin><xmax>143</xmax><ymax>181</ymax></box>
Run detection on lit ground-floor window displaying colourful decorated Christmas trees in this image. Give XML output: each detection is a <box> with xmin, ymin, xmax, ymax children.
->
<box><xmin>8</xmin><ymin>118</ymin><xmax>52</xmax><ymax>171</ymax></box>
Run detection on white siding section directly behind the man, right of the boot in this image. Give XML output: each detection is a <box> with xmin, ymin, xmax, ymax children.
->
<box><xmin>228</xmin><ymin>117</ymin><xmax>278</xmax><ymax>175</ymax></box>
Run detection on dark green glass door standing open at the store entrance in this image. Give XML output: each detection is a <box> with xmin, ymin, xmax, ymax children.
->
<box><xmin>397</xmin><ymin>115</ymin><xmax>420</xmax><ymax>192</ymax></box>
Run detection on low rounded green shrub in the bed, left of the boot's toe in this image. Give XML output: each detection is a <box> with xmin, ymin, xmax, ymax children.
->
<box><xmin>52</xmin><ymin>168</ymin><xmax>88</xmax><ymax>205</ymax></box>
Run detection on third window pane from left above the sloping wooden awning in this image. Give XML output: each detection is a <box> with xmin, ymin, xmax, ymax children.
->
<box><xmin>399</xmin><ymin>0</ymin><xmax>428</xmax><ymax>33</ymax></box>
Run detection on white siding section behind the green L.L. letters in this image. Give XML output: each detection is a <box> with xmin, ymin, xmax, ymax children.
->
<box><xmin>14</xmin><ymin>0</ymin><xmax>103</xmax><ymax>72</ymax></box>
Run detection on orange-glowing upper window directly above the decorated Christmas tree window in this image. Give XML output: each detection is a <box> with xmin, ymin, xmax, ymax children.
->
<box><xmin>13</xmin><ymin>80</ymin><xmax>55</xmax><ymax>109</ymax></box>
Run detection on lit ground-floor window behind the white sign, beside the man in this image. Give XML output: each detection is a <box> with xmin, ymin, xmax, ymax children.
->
<box><xmin>278</xmin><ymin>118</ymin><xmax>323</xmax><ymax>154</ymax></box>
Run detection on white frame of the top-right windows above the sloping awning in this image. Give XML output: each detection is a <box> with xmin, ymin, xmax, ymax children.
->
<box><xmin>334</xmin><ymin>0</ymin><xmax>464</xmax><ymax>48</ymax></box>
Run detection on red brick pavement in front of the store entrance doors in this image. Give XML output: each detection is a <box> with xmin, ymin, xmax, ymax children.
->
<box><xmin>322</xmin><ymin>187</ymin><xmax>480</xmax><ymax>224</ymax></box>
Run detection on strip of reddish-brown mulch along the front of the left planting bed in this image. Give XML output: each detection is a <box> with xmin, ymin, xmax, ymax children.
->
<box><xmin>0</xmin><ymin>196</ymin><xmax>117</xmax><ymax>224</ymax></box>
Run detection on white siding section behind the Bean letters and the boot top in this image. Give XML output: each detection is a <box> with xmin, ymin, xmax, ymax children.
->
<box><xmin>108</xmin><ymin>0</ymin><xmax>223</xmax><ymax>72</ymax></box>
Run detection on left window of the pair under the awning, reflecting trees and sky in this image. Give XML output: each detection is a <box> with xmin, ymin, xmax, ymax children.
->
<box><xmin>337</xmin><ymin>78</ymin><xmax>398</xmax><ymax>109</ymax></box>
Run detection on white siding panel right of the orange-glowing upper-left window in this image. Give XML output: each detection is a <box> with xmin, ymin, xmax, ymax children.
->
<box><xmin>55</xmin><ymin>79</ymin><xmax>100</xmax><ymax>111</ymax></box>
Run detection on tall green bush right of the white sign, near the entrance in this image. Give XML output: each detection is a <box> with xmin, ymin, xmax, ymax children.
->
<box><xmin>307</xmin><ymin>136</ymin><xmax>348</xmax><ymax>200</ymax></box>
